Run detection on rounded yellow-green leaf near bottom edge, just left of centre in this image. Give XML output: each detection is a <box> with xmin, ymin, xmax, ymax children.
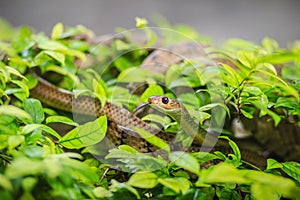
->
<box><xmin>127</xmin><ymin>171</ymin><xmax>158</xmax><ymax>188</ymax></box>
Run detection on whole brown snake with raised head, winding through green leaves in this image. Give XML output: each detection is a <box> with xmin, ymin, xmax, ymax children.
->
<box><xmin>30</xmin><ymin>35</ymin><xmax>265</xmax><ymax>168</ymax></box>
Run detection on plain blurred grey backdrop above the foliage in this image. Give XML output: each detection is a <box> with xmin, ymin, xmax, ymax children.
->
<box><xmin>0</xmin><ymin>0</ymin><xmax>300</xmax><ymax>47</ymax></box>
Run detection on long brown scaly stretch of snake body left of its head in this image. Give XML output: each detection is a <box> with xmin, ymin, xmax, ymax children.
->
<box><xmin>30</xmin><ymin>77</ymin><xmax>159</xmax><ymax>133</ymax></box>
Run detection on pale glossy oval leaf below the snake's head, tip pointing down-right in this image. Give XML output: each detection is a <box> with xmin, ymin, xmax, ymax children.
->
<box><xmin>169</xmin><ymin>151</ymin><xmax>200</xmax><ymax>174</ymax></box>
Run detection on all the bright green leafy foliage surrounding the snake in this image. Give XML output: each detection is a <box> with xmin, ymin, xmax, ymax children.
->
<box><xmin>0</xmin><ymin>18</ymin><xmax>300</xmax><ymax>199</ymax></box>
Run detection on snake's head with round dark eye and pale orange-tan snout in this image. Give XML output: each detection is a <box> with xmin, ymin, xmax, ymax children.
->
<box><xmin>148</xmin><ymin>96</ymin><xmax>181</xmax><ymax>117</ymax></box>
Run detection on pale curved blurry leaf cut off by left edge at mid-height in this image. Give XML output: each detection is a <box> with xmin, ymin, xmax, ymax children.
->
<box><xmin>0</xmin><ymin>105</ymin><xmax>33</xmax><ymax>124</ymax></box>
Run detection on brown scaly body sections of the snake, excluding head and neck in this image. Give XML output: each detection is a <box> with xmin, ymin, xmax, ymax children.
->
<box><xmin>30</xmin><ymin>38</ymin><xmax>265</xmax><ymax>167</ymax></box>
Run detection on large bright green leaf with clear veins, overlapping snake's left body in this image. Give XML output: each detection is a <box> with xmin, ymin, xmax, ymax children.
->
<box><xmin>59</xmin><ymin>116</ymin><xmax>107</xmax><ymax>149</ymax></box>
